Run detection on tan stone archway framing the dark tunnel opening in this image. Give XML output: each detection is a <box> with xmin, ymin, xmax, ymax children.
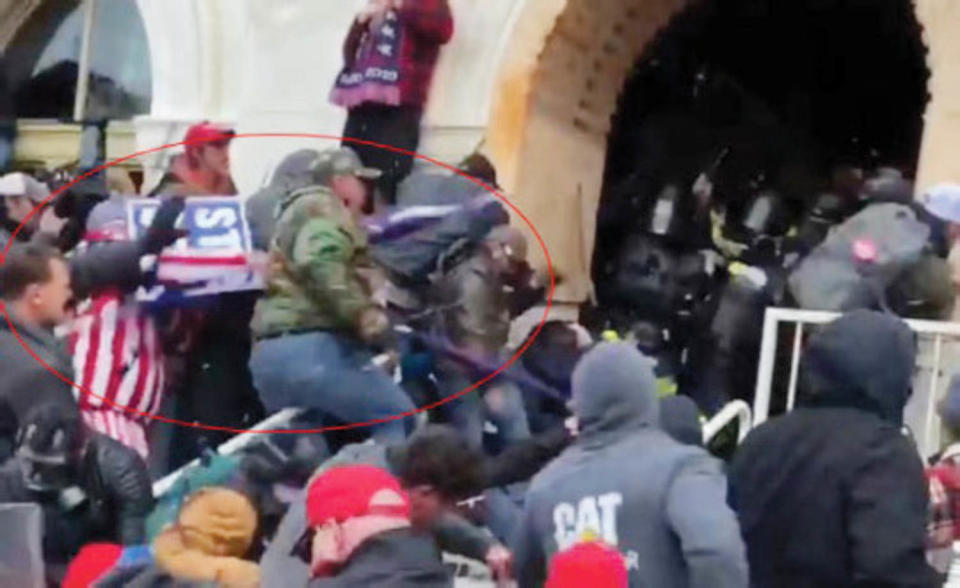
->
<box><xmin>485</xmin><ymin>0</ymin><xmax>960</xmax><ymax>303</ymax></box>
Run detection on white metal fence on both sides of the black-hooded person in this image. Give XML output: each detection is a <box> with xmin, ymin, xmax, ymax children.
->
<box><xmin>753</xmin><ymin>308</ymin><xmax>960</xmax><ymax>456</ymax></box>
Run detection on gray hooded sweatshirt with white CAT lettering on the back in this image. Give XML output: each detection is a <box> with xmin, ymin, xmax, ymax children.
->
<box><xmin>513</xmin><ymin>343</ymin><xmax>748</xmax><ymax>588</ymax></box>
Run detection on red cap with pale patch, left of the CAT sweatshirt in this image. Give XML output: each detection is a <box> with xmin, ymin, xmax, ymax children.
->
<box><xmin>307</xmin><ymin>465</ymin><xmax>410</xmax><ymax>527</ymax></box>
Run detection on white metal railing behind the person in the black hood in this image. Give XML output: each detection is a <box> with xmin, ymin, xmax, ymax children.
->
<box><xmin>753</xmin><ymin>308</ymin><xmax>960</xmax><ymax>455</ymax></box>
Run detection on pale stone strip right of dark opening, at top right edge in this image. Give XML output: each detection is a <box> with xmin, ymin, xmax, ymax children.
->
<box><xmin>914</xmin><ymin>0</ymin><xmax>960</xmax><ymax>196</ymax></box>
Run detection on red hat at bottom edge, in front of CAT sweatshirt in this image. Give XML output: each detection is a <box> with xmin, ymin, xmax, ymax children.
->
<box><xmin>545</xmin><ymin>541</ymin><xmax>628</xmax><ymax>588</ymax></box>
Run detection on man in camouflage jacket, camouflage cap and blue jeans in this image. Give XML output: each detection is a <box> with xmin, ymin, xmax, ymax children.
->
<box><xmin>250</xmin><ymin>148</ymin><xmax>413</xmax><ymax>442</ymax></box>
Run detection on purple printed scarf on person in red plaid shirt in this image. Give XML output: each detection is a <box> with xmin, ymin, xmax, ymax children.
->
<box><xmin>330</xmin><ymin>10</ymin><xmax>404</xmax><ymax>108</ymax></box>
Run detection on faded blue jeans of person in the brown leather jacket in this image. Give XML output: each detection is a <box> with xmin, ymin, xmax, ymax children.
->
<box><xmin>434</xmin><ymin>361</ymin><xmax>530</xmax><ymax>449</ymax></box>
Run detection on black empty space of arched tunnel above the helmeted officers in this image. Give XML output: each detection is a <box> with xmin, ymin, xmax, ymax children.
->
<box><xmin>593</xmin><ymin>0</ymin><xmax>928</xmax><ymax>307</ymax></box>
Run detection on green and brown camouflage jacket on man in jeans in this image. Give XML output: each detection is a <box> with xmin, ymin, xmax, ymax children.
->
<box><xmin>252</xmin><ymin>186</ymin><xmax>373</xmax><ymax>338</ymax></box>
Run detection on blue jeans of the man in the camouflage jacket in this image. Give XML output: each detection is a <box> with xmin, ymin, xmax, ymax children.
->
<box><xmin>250</xmin><ymin>331</ymin><xmax>414</xmax><ymax>444</ymax></box>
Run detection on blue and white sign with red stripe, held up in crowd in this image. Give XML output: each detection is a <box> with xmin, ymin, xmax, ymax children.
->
<box><xmin>127</xmin><ymin>196</ymin><xmax>263</xmax><ymax>300</ymax></box>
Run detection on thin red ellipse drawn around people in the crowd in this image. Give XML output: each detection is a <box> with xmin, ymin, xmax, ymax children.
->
<box><xmin>0</xmin><ymin>133</ymin><xmax>556</xmax><ymax>434</ymax></box>
